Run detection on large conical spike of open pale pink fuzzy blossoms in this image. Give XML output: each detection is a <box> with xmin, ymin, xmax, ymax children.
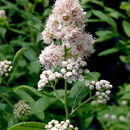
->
<box><xmin>38</xmin><ymin>0</ymin><xmax>94</xmax><ymax>90</ymax></box>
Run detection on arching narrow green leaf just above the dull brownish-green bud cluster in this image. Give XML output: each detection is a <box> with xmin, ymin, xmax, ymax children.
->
<box><xmin>16</xmin><ymin>85</ymin><xmax>44</xmax><ymax>97</ymax></box>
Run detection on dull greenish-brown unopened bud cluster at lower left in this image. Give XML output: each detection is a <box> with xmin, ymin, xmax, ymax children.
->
<box><xmin>14</xmin><ymin>100</ymin><xmax>30</xmax><ymax>119</ymax></box>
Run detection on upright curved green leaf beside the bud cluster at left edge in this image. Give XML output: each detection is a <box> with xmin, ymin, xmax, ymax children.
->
<box><xmin>13</xmin><ymin>48</ymin><xmax>26</xmax><ymax>68</ymax></box>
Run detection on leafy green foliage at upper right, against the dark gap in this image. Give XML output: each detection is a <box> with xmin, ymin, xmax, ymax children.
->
<box><xmin>81</xmin><ymin>0</ymin><xmax>130</xmax><ymax>64</ymax></box>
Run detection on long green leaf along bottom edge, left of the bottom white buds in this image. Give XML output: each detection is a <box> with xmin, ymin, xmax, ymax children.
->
<box><xmin>8</xmin><ymin>122</ymin><xmax>45</xmax><ymax>130</ymax></box>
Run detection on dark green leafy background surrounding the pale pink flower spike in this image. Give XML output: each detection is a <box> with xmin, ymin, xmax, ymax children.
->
<box><xmin>0</xmin><ymin>0</ymin><xmax>130</xmax><ymax>130</ymax></box>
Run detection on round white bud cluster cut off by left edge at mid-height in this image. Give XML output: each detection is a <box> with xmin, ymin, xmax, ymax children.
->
<box><xmin>0</xmin><ymin>60</ymin><xmax>12</xmax><ymax>76</ymax></box>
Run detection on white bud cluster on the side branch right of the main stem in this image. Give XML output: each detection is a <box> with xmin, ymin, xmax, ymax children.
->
<box><xmin>85</xmin><ymin>80</ymin><xmax>112</xmax><ymax>103</ymax></box>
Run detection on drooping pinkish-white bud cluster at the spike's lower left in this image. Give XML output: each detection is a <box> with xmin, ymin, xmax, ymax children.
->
<box><xmin>38</xmin><ymin>70</ymin><xmax>62</xmax><ymax>91</ymax></box>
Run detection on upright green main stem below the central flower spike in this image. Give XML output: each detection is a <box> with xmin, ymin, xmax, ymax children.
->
<box><xmin>64</xmin><ymin>80</ymin><xmax>69</xmax><ymax>119</ymax></box>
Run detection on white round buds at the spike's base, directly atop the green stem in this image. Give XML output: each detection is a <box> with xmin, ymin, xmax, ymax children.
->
<box><xmin>61</xmin><ymin>57</ymin><xmax>87</xmax><ymax>83</ymax></box>
